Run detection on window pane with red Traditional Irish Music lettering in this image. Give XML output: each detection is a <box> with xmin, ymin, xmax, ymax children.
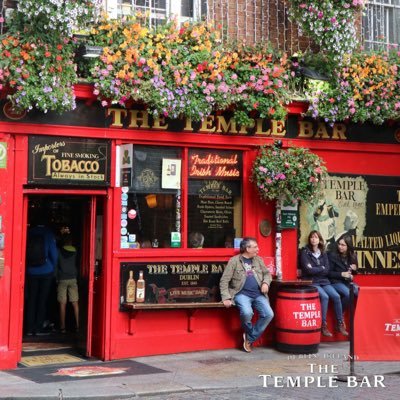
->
<box><xmin>187</xmin><ymin>149</ymin><xmax>242</xmax><ymax>248</ymax></box>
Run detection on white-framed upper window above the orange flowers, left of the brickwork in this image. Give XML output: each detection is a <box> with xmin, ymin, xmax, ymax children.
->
<box><xmin>105</xmin><ymin>0</ymin><xmax>207</xmax><ymax>26</ymax></box>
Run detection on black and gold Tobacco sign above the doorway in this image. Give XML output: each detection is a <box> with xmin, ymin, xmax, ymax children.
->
<box><xmin>28</xmin><ymin>136</ymin><xmax>111</xmax><ymax>186</ymax></box>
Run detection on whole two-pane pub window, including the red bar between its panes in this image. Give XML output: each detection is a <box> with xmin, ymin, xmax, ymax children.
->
<box><xmin>118</xmin><ymin>144</ymin><xmax>242</xmax><ymax>249</ymax></box>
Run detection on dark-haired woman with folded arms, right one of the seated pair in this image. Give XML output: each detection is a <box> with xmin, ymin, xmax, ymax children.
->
<box><xmin>328</xmin><ymin>236</ymin><xmax>358</xmax><ymax>309</ymax></box>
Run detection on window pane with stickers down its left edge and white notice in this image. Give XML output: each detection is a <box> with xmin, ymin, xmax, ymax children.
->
<box><xmin>120</xmin><ymin>144</ymin><xmax>181</xmax><ymax>249</ymax></box>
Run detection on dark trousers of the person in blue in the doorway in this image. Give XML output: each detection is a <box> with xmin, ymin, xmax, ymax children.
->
<box><xmin>26</xmin><ymin>274</ymin><xmax>53</xmax><ymax>333</ymax></box>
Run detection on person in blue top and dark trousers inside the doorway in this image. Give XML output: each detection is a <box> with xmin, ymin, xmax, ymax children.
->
<box><xmin>26</xmin><ymin>214</ymin><xmax>58</xmax><ymax>335</ymax></box>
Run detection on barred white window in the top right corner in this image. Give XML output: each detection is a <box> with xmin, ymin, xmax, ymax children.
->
<box><xmin>363</xmin><ymin>0</ymin><xmax>400</xmax><ymax>50</ymax></box>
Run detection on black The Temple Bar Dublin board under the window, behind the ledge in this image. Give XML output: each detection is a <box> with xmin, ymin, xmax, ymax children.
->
<box><xmin>120</xmin><ymin>261</ymin><xmax>225</xmax><ymax>304</ymax></box>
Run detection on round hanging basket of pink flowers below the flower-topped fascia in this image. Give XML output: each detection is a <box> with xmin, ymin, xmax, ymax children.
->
<box><xmin>250</xmin><ymin>142</ymin><xmax>327</xmax><ymax>203</ymax></box>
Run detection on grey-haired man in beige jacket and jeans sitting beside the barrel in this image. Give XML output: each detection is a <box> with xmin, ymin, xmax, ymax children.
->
<box><xmin>220</xmin><ymin>237</ymin><xmax>274</xmax><ymax>353</ymax></box>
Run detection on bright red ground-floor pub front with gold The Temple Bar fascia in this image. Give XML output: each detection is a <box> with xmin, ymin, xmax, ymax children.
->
<box><xmin>0</xmin><ymin>87</ymin><xmax>400</xmax><ymax>369</ymax></box>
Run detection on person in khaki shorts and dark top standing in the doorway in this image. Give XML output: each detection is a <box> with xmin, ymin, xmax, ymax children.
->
<box><xmin>56</xmin><ymin>234</ymin><xmax>79</xmax><ymax>333</ymax></box>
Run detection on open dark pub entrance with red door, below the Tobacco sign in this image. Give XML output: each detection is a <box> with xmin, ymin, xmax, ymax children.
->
<box><xmin>21</xmin><ymin>192</ymin><xmax>104</xmax><ymax>366</ymax></box>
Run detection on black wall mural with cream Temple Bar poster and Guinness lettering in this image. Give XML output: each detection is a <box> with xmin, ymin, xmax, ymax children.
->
<box><xmin>299</xmin><ymin>174</ymin><xmax>400</xmax><ymax>274</ymax></box>
